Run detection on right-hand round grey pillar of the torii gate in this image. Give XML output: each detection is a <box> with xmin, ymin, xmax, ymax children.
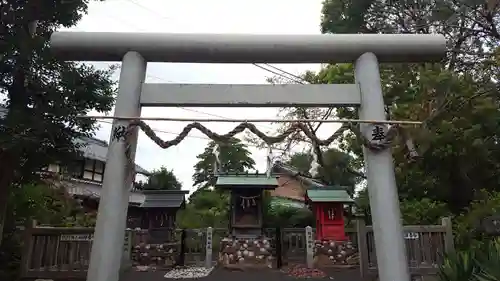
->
<box><xmin>355</xmin><ymin>53</ymin><xmax>410</xmax><ymax>281</ymax></box>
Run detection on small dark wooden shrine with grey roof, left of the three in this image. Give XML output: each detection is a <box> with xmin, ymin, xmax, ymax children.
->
<box><xmin>139</xmin><ymin>190</ymin><xmax>189</xmax><ymax>229</ymax></box>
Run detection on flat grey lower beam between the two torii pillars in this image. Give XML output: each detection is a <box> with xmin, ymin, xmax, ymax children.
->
<box><xmin>141</xmin><ymin>83</ymin><xmax>361</xmax><ymax>107</ymax></box>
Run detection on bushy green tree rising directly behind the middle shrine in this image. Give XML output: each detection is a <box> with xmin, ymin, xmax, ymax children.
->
<box><xmin>193</xmin><ymin>138</ymin><xmax>255</xmax><ymax>189</ymax></box>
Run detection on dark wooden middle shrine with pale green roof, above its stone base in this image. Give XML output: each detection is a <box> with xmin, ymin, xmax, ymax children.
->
<box><xmin>215</xmin><ymin>174</ymin><xmax>278</xmax><ymax>238</ymax></box>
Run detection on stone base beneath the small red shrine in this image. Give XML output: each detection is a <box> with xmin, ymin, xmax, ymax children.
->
<box><xmin>314</xmin><ymin>240</ymin><xmax>359</xmax><ymax>268</ymax></box>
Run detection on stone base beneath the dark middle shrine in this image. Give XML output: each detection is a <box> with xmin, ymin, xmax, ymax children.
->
<box><xmin>219</xmin><ymin>237</ymin><xmax>275</xmax><ymax>270</ymax></box>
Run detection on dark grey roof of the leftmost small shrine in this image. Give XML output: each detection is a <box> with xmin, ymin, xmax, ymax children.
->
<box><xmin>140</xmin><ymin>190</ymin><xmax>189</xmax><ymax>208</ymax></box>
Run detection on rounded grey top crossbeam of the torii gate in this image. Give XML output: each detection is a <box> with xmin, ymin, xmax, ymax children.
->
<box><xmin>50</xmin><ymin>32</ymin><xmax>446</xmax><ymax>63</ymax></box>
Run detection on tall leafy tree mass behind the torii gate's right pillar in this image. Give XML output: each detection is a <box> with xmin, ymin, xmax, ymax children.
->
<box><xmin>317</xmin><ymin>0</ymin><xmax>500</xmax><ymax>213</ymax></box>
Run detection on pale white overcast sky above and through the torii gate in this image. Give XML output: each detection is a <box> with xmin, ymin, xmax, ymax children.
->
<box><xmin>63</xmin><ymin>0</ymin><xmax>331</xmax><ymax>191</ymax></box>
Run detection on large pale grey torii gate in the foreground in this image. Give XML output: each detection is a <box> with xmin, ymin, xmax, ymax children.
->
<box><xmin>51</xmin><ymin>32</ymin><xmax>446</xmax><ymax>281</ymax></box>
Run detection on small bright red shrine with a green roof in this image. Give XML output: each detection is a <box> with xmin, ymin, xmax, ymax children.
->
<box><xmin>305</xmin><ymin>186</ymin><xmax>354</xmax><ymax>241</ymax></box>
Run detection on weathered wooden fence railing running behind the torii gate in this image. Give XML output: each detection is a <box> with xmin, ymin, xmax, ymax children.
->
<box><xmin>21</xmin><ymin>218</ymin><xmax>454</xmax><ymax>279</ymax></box>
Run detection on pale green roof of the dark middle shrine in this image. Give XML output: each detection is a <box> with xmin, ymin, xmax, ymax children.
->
<box><xmin>215</xmin><ymin>174</ymin><xmax>278</xmax><ymax>189</ymax></box>
